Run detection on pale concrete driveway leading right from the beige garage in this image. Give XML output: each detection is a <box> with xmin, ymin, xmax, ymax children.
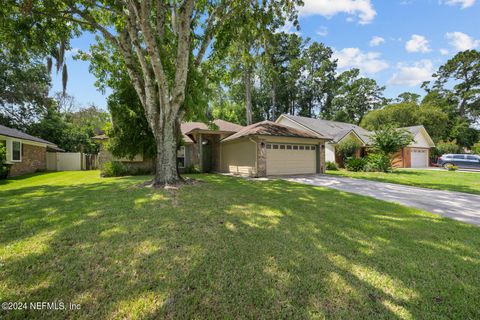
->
<box><xmin>282</xmin><ymin>175</ymin><xmax>480</xmax><ymax>226</ymax></box>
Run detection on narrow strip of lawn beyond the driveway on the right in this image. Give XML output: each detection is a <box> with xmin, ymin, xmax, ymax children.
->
<box><xmin>327</xmin><ymin>169</ymin><xmax>480</xmax><ymax>194</ymax></box>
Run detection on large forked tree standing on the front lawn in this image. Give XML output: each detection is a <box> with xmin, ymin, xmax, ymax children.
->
<box><xmin>4</xmin><ymin>0</ymin><xmax>296</xmax><ymax>186</ymax></box>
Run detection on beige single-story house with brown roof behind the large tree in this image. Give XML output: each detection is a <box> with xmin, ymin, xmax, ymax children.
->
<box><xmin>96</xmin><ymin>120</ymin><xmax>331</xmax><ymax>177</ymax></box>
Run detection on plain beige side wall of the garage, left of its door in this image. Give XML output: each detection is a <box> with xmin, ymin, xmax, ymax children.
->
<box><xmin>220</xmin><ymin>138</ymin><xmax>257</xmax><ymax>176</ymax></box>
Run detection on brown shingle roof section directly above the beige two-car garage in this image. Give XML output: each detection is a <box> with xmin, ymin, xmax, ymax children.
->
<box><xmin>222</xmin><ymin>121</ymin><xmax>328</xmax><ymax>142</ymax></box>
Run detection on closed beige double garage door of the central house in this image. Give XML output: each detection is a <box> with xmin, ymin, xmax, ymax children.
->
<box><xmin>267</xmin><ymin>143</ymin><xmax>317</xmax><ymax>175</ymax></box>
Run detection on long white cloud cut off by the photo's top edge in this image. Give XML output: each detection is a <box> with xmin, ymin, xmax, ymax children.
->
<box><xmin>299</xmin><ymin>0</ymin><xmax>377</xmax><ymax>24</ymax></box>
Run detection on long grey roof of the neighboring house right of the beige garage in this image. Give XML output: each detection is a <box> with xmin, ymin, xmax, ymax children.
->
<box><xmin>277</xmin><ymin>114</ymin><xmax>372</xmax><ymax>145</ymax></box>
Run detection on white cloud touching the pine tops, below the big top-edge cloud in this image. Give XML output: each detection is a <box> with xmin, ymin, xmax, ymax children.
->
<box><xmin>333</xmin><ymin>48</ymin><xmax>389</xmax><ymax>74</ymax></box>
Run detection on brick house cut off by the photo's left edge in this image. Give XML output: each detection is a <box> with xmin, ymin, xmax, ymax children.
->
<box><xmin>0</xmin><ymin>125</ymin><xmax>62</xmax><ymax>177</ymax></box>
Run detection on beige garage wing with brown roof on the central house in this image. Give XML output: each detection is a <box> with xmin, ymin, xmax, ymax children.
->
<box><xmin>220</xmin><ymin>121</ymin><xmax>331</xmax><ymax>177</ymax></box>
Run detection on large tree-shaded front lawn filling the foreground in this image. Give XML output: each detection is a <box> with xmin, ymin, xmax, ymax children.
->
<box><xmin>0</xmin><ymin>171</ymin><xmax>480</xmax><ymax>319</ymax></box>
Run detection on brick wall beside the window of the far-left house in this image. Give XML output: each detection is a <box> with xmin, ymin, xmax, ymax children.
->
<box><xmin>9</xmin><ymin>143</ymin><xmax>47</xmax><ymax>177</ymax></box>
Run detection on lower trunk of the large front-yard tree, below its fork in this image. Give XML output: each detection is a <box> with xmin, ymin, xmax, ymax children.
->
<box><xmin>152</xmin><ymin>116</ymin><xmax>182</xmax><ymax>187</ymax></box>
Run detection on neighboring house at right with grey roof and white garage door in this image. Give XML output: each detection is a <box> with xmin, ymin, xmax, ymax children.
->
<box><xmin>276</xmin><ymin>114</ymin><xmax>435</xmax><ymax>168</ymax></box>
